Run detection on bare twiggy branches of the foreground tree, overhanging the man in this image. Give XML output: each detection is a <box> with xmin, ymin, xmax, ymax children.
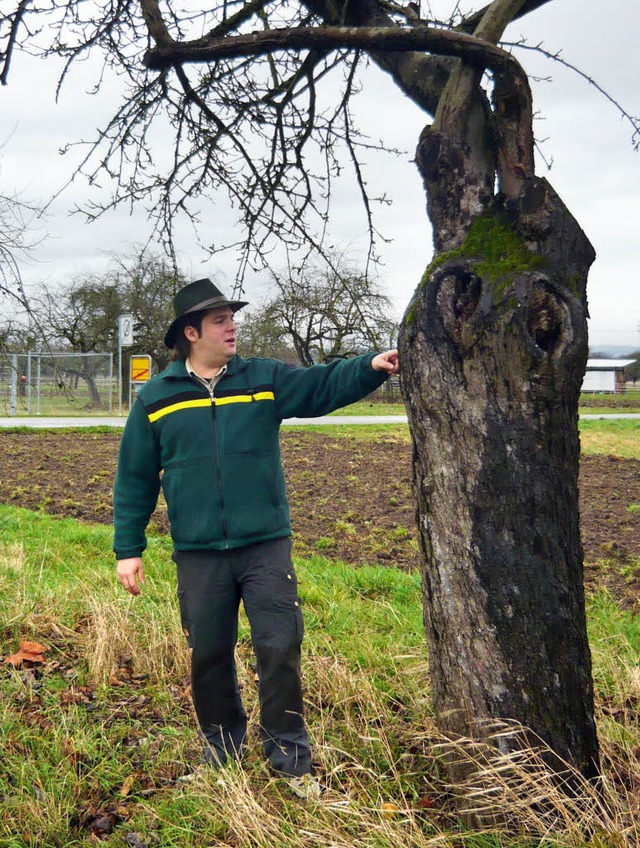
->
<box><xmin>0</xmin><ymin>0</ymin><xmax>518</xmax><ymax>282</ymax></box>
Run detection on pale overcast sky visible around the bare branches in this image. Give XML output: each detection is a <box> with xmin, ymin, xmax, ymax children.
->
<box><xmin>0</xmin><ymin>0</ymin><xmax>640</xmax><ymax>348</ymax></box>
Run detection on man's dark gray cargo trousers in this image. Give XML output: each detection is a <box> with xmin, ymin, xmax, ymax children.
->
<box><xmin>173</xmin><ymin>538</ymin><xmax>311</xmax><ymax>776</ymax></box>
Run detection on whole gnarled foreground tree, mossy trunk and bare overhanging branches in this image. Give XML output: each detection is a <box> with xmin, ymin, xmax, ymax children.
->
<box><xmin>2</xmin><ymin>0</ymin><xmax>637</xmax><ymax>796</ymax></box>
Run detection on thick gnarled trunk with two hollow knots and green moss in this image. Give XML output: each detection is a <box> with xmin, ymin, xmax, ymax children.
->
<box><xmin>400</xmin><ymin>122</ymin><xmax>598</xmax><ymax>792</ymax></box>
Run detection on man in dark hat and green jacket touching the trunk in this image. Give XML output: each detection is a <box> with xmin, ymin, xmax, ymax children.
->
<box><xmin>114</xmin><ymin>279</ymin><xmax>398</xmax><ymax>797</ymax></box>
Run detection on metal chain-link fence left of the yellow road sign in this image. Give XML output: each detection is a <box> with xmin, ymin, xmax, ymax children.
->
<box><xmin>0</xmin><ymin>352</ymin><xmax>117</xmax><ymax>416</ymax></box>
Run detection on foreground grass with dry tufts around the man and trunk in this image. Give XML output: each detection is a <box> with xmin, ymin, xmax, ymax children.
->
<box><xmin>0</xmin><ymin>486</ymin><xmax>640</xmax><ymax>848</ymax></box>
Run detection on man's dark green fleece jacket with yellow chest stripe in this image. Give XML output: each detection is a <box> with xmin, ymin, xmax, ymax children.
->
<box><xmin>113</xmin><ymin>354</ymin><xmax>387</xmax><ymax>559</ymax></box>
